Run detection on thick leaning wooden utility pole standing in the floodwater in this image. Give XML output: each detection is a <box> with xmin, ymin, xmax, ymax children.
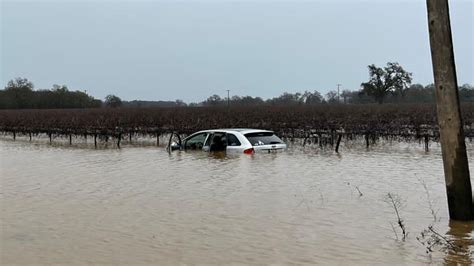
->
<box><xmin>426</xmin><ymin>0</ymin><xmax>474</xmax><ymax>221</ymax></box>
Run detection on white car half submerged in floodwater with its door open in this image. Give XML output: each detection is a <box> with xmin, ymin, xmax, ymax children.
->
<box><xmin>171</xmin><ymin>128</ymin><xmax>286</xmax><ymax>154</ymax></box>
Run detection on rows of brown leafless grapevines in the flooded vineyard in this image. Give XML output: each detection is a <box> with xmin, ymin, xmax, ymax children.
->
<box><xmin>0</xmin><ymin>103</ymin><xmax>474</xmax><ymax>148</ymax></box>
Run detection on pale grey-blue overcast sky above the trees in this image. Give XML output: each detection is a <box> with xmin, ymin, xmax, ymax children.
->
<box><xmin>0</xmin><ymin>0</ymin><xmax>474</xmax><ymax>102</ymax></box>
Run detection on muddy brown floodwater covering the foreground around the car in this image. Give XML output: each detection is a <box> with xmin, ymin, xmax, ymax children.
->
<box><xmin>0</xmin><ymin>139</ymin><xmax>474</xmax><ymax>265</ymax></box>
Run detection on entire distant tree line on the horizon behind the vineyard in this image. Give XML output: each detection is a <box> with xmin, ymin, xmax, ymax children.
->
<box><xmin>0</xmin><ymin>62</ymin><xmax>474</xmax><ymax>109</ymax></box>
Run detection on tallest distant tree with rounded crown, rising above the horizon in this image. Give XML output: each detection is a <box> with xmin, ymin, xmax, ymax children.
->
<box><xmin>361</xmin><ymin>62</ymin><xmax>412</xmax><ymax>104</ymax></box>
